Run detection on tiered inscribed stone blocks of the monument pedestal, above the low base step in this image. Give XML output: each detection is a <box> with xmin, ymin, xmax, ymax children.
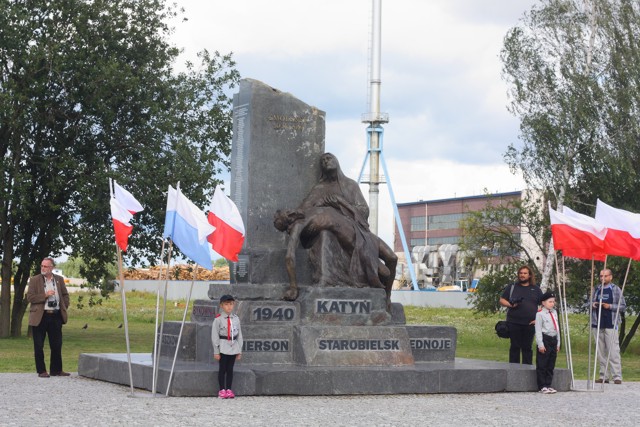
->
<box><xmin>152</xmin><ymin>285</ymin><xmax>438</xmax><ymax>367</ymax></box>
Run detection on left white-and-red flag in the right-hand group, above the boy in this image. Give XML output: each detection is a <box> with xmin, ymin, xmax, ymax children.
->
<box><xmin>549</xmin><ymin>205</ymin><xmax>607</xmax><ymax>261</ymax></box>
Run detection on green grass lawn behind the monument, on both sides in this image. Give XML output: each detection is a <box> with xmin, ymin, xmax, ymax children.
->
<box><xmin>0</xmin><ymin>292</ymin><xmax>640</xmax><ymax>381</ymax></box>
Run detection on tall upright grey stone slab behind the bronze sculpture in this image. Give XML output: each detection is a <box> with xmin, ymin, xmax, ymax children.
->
<box><xmin>231</xmin><ymin>79</ymin><xmax>325</xmax><ymax>286</ymax></box>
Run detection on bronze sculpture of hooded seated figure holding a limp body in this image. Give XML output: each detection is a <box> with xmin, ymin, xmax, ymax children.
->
<box><xmin>274</xmin><ymin>153</ymin><xmax>397</xmax><ymax>309</ymax></box>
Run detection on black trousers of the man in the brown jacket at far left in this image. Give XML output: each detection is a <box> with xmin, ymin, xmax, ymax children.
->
<box><xmin>32</xmin><ymin>311</ymin><xmax>62</xmax><ymax>374</ymax></box>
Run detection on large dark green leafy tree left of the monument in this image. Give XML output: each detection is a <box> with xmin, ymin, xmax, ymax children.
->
<box><xmin>0</xmin><ymin>0</ymin><xmax>239</xmax><ymax>337</ymax></box>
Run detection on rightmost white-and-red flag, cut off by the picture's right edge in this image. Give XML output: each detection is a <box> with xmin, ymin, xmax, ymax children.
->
<box><xmin>596</xmin><ymin>199</ymin><xmax>640</xmax><ymax>261</ymax></box>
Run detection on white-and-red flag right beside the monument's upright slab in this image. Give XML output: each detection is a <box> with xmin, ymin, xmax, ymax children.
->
<box><xmin>207</xmin><ymin>187</ymin><xmax>245</xmax><ymax>262</ymax></box>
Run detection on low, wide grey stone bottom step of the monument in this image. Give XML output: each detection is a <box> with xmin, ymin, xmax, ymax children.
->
<box><xmin>78</xmin><ymin>353</ymin><xmax>571</xmax><ymax>397</ymax></box>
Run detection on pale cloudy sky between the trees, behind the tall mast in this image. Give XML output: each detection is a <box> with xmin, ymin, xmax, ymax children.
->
<box><xmin>171</xmin><ymin>0</ymin><xmax>536</xmax><ymax>245</ymax></box>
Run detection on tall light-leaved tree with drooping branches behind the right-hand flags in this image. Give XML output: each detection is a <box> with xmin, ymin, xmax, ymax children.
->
<box><xmin>501</xmin><ymin>0</ymin><xmax>640</xmax><ymax>350</ymax></box>
